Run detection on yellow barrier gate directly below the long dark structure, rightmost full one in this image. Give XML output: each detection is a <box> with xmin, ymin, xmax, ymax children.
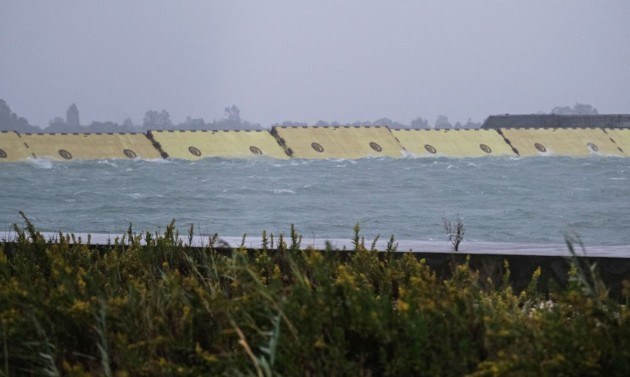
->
<box><xmin>501</xmin><ymin>128</ymin><xmax>623</xmax><ymax>157</ymax></box>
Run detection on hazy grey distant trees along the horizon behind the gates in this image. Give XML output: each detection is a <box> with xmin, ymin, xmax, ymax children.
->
<box><xmin>0</xmin><ymin>99</ymin><xmax>598</xmax><ymax>133</ymax></box>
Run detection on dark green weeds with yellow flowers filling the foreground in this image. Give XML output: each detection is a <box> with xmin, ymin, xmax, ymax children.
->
<box><xmin>0</xmin><ymin>216</ymin><xmax>630</xmax><ymax>376</ymax></box>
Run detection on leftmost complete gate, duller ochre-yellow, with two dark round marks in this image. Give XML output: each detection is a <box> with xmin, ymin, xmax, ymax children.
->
<box><xmin>22</xmin><ymin>133</ymin><xmax>161</xmax><ymax>161</ymax></box>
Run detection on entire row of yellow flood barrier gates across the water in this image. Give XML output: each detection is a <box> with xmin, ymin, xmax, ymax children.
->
<box><xmin>0</xmin><ymin>126</ymin><xmax>630</xmax><ymax>162</ymax></box>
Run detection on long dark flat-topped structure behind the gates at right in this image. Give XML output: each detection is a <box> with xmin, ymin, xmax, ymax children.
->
<box><xmin>481</xmin><ymin>114</ymin><xmax>630</xmax><ymax>129</ymax></box>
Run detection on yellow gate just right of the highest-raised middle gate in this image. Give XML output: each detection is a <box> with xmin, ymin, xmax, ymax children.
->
<box><xmin>392</xmin><ymin>129</ymin><xmax>516</xmax><ymax>157</ymax></box>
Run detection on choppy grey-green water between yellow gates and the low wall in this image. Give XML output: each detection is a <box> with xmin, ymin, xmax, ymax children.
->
<box><xmin>0</xmin><ymin>157</ymin><xmax>630</xmax><ymax>246</ymax></box>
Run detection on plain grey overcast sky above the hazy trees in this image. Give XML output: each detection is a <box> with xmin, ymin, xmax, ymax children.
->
<box><xmin>0</xmin><ymin>0</ymin><xmax>630</xmax><ymax>127</ymax></box>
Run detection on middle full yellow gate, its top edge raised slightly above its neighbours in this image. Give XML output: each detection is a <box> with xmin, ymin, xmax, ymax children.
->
<box><xmin>272</xmin><ymin>126</ymin><xmax>403</xmax><ymax>159</ymax></box>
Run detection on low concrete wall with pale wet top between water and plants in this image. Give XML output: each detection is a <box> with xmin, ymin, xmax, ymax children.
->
<box><xmin>0</xmin><ymin>232</ymin><xmax>630</xmax><ymax>299</ymax></box>
